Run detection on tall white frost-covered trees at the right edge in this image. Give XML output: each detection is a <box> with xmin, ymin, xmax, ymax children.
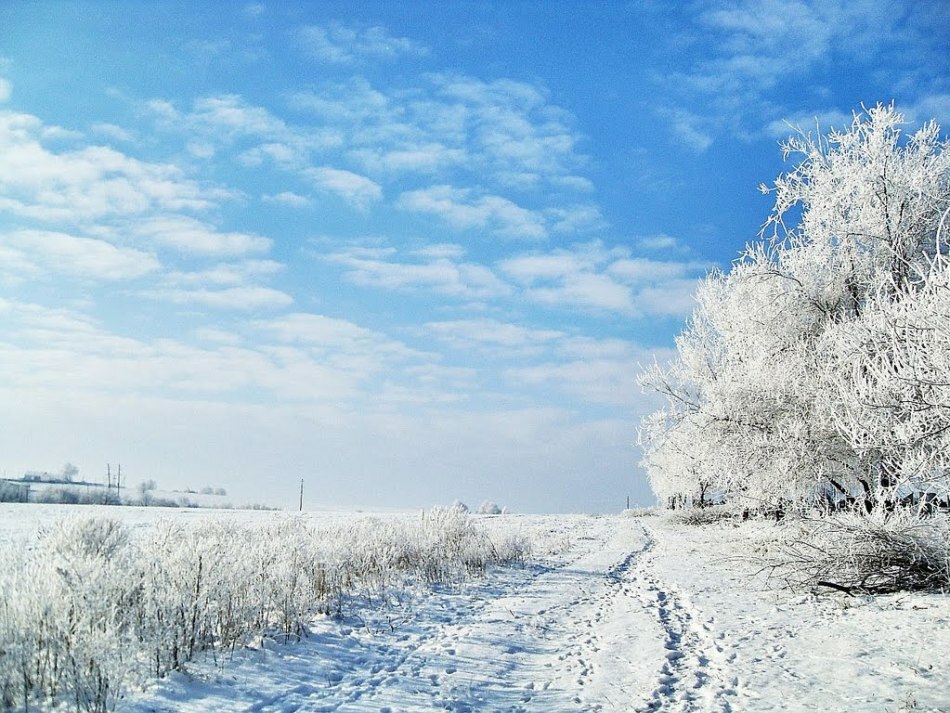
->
<box><xmin>640</xmin><ymin>105</ymin><xmax>950</xmax><ymax>510</ymax></box>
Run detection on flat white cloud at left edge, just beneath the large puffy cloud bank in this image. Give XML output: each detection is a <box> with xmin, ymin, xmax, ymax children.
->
<box><xmin>0</xmin><ymin>230</ymin><xmax>160</xmax><ymax>280</ymax></box>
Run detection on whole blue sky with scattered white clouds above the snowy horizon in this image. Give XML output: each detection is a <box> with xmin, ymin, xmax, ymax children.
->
<box><xmin>0</xmin><ymin>0</ymin><xmax>950</xmax><ymax>512</ymax></box>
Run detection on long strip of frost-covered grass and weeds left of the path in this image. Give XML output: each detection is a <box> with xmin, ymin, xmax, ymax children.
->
<box><xmin>0</xmin><ymin>508</ymin><xmax>528</xmax><ymax>711</ymax></box>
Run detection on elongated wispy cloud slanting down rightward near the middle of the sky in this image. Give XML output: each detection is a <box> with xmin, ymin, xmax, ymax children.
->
<box><xmin>396</xmin><ymin>185</ymin><xmax>547</xmax><ymax>240</ymax></box>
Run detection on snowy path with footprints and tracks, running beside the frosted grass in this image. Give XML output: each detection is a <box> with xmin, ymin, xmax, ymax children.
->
<box><xmin>128</xmin><ymin>518</ymin><xmax>729</xmax><ymax>713</ymax></box>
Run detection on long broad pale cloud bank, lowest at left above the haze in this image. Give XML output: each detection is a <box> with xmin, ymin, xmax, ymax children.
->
<box><xmin>0</xmin><ymin>304</ymin><xmax>370</xmax><ymax>400</ymax></box>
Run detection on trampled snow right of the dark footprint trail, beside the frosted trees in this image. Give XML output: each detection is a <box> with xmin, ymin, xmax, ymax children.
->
<box><xmin>643</xmin><ymin>518</ymin><xmax>950</xmax><ymax>711</ymax></box>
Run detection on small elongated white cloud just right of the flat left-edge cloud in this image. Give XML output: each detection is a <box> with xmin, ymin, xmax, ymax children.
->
<box><xmin>130</xmin><ymin>215</ymin><xmax>271</xmax><ymax>256</ymax></box>
